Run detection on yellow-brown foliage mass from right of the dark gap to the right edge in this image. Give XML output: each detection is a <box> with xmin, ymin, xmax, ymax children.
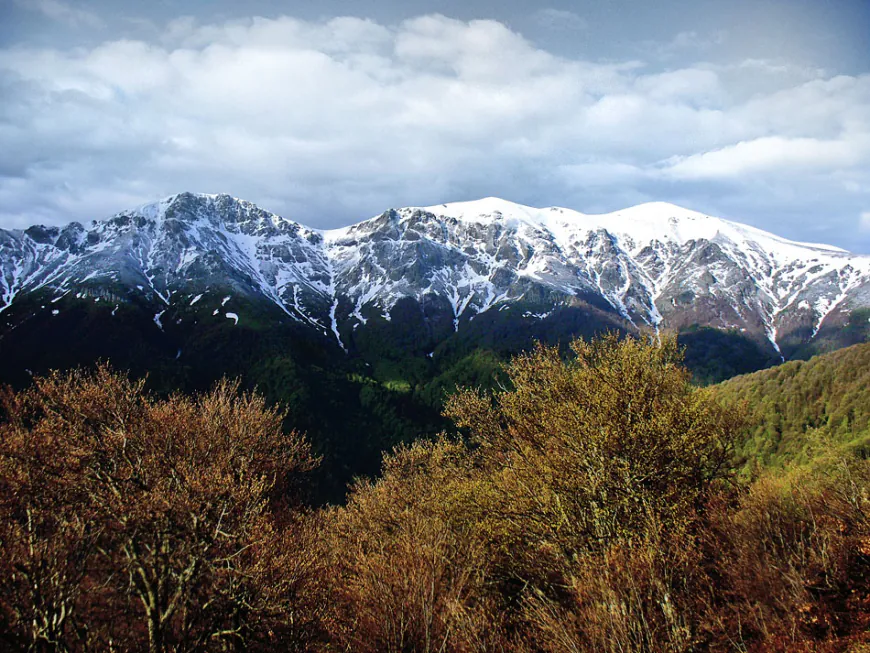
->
<box><xmin>327</xmin><ymin>336</ymin><xmax>870</xmax><ymax>653</ymax></box>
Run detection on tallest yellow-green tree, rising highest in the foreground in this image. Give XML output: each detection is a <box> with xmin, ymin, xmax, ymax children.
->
<box><xmin>436</xmin><ymin>334</ymin><xmax>743</xmax><ymax>651</ymax></box>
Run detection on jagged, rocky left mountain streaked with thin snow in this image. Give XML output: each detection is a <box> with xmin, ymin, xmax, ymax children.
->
<box><xmin>0</xmin><ymin>193</ymin><xmax>330</xmax><ymax>327</ymax></box>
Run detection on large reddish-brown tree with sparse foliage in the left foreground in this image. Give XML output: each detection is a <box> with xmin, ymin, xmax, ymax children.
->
<box><xmin>0</xmin><ymin>366</ymin><xmax>316</xmax><ymax>653</ymax></box>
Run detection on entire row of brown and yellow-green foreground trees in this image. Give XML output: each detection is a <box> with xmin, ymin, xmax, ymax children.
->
<box><xmin>0</xmin><ymin>335</ymin><xmax>870</xmax><ymax>653</ymax></box>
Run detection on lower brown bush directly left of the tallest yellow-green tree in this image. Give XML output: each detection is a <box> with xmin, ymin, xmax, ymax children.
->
<box><xmin>331</xmin><ymin>439</ymin><xmax>508</xmax><ymax>652</ymax></box>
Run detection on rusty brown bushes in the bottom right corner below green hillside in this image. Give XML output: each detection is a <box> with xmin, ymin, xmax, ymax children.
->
<box><xmin>706</xmin><ymin>455</ymin><xmax>870</xmax><ymax>651</ymax></box>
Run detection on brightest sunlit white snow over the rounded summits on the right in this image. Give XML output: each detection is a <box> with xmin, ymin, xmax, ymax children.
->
<box><xmin>412</xmin><ymin>198</ymin><xmax>870</xmax><ymax>345</ymax></box>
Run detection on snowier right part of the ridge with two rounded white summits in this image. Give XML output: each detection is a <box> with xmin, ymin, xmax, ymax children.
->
<box><xmin>326</xmin><ymin>198</ymin><xmax>870</xmax><ymax>351</ymax></box>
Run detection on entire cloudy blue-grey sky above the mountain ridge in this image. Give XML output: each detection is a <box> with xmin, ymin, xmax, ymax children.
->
<box><xmin>0</xmin><ymin>0</ymin><xmax>870</xmax><ymax>254</ymax></box>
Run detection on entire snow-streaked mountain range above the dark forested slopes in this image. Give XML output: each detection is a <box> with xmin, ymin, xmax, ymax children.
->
<box><xmin>0</xmin><ymin>193</ymin><xmax>870</xmax><ymax>356</ymax></box>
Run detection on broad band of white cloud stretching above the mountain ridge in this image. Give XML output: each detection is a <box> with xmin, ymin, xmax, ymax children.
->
<box><xmin>0</xmin><ymin>15</ymin><xmax>870</xmax><ymax>246</ymax></box>
